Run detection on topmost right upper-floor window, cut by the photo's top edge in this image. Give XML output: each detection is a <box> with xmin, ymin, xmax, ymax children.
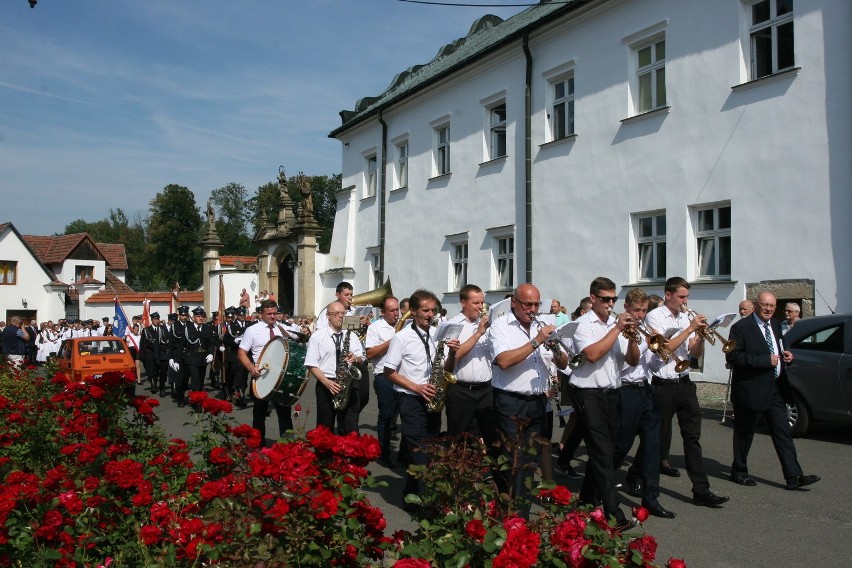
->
<box><xmin>745</xmin><ymin>0</ymin><xmax>796</xmax><ymax>81</ymax></box>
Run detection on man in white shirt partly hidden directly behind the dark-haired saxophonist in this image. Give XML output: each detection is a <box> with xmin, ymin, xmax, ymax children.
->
<box><xmin>365</xmin><ymin>296</ymin><xmax>399</xmax><ymax>468</ymax></box>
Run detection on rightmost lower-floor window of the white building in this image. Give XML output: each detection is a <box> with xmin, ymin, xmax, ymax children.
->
<box><xmin>692</xmin><ymin>202</ymin><xmax>733</xmax><ymax>280</ymax></box>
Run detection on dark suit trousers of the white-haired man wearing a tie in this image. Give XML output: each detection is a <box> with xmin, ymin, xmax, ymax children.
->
<box><xmin>731</xmin><ymin>388</ymin><xmax>802</xmax><ymax>479</ymax></box>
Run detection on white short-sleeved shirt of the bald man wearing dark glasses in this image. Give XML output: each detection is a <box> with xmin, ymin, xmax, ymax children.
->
<box><xmin>488</xmin><ymin>312</ymin><xmax>553</xmax><ymax>395</ymax></box>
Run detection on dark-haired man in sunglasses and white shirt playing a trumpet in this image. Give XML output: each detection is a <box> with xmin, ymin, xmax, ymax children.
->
<box><xmin>570</xmin><ymin>276</ymin><xmax>639</xmax><ymax>528</ymax></box>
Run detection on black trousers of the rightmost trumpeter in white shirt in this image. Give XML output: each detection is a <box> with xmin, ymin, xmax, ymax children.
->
<box><xmin>653</xmin><ymin>379</ymin><xmax>710</xmax><ymax>495</ymax></box>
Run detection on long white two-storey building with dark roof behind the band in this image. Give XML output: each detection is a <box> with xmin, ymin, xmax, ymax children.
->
<box><xmin>317</xmin><ymin>0</ymin><xmax>852</xmax><ymax>381</ymax></box>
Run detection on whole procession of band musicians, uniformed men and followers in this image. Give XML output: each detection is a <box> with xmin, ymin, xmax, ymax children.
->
<box><xmin>2</xmin><ymin>277</ymin><xmax>819</xmax><ymax>527</ymax></box>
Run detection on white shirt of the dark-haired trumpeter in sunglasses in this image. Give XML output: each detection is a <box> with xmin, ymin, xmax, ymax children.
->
<box><xmin>570</xmin><ymin>310</ymin><xmax>627</xmax><ymax>389</ymax></box>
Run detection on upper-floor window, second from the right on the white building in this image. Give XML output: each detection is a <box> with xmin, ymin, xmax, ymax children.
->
<box><xmin>622</xmin><ymin>20</ymin><xmax>669</xmax><ymax>116</ymax></box>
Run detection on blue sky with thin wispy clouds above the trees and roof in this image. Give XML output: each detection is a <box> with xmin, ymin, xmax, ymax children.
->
<box><xmin>0</xmin><ymin>0</ymin><xmax>523</xmax><ymax>234</ymax></box>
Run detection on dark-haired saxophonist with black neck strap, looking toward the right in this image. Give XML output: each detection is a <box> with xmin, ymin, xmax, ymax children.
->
<box><xmin>384</xmin><ymin>290</ymin><xmax>458</xmax><ymax>504</ymax></box>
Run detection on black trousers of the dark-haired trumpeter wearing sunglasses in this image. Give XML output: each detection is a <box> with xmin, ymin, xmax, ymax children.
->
<box><xmin>573</xmin><ymin>389</ymin><xmax>624</xmax><ymax>522</ymax></box>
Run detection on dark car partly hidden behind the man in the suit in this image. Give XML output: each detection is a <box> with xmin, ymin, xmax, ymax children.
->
<box><xmin>784</xmin><ymin>314</ymin><xmax>852</xmax><ymax>436</ymax></box>
